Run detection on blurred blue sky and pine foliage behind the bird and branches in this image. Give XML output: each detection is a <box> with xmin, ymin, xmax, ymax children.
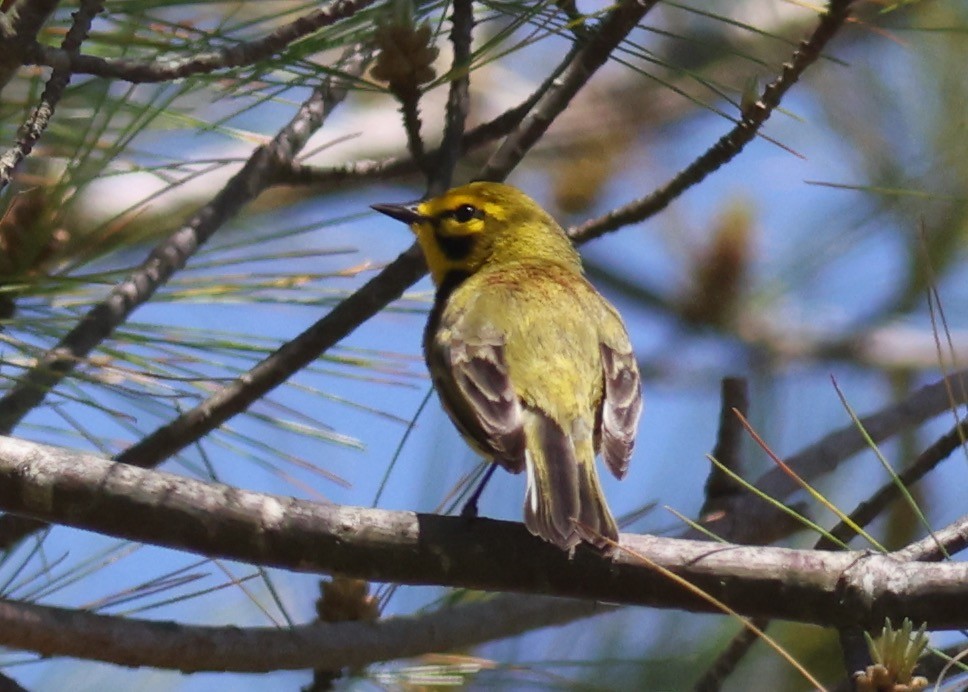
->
<box><xmin>0</xmin><ymin>0</ymin><xmax>968</xmax><ymax>690</ymax></box>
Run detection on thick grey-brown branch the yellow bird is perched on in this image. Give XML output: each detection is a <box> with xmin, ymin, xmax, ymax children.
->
<box><xmin>0</xmin><ymin>438</ymin><xmax>968</xmax><ymax>629</ymax></box>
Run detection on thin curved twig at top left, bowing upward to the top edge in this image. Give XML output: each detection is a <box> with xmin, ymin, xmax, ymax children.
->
<box><xmin>26</xmin><ymin>0</ymin><xmax>374</xmax><ymax>83</ymax></box>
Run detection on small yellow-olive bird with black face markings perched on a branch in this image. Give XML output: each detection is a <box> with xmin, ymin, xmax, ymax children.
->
<box><xmin>373</xmin><ymin>182</ymin><xmax>642</xmax><ymax>551</ymax></box>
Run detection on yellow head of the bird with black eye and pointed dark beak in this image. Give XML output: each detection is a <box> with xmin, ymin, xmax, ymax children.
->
<box><xmin>373</xmin><ymin>183</ymin><xmax>581</xmax><ymax>285</ymax></box>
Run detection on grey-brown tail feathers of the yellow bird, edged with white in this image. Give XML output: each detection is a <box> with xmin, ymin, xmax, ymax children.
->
<box><xmin>524</xmin><ymin>410</ymin><xmax>618</xmax><ymax>551</ymax></box>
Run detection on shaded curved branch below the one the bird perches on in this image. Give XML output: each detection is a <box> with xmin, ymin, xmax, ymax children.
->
<box><xmin>0</xmin><ymin>596</ymin><xmax>611</xmax><ymax>673</ymax></box>
